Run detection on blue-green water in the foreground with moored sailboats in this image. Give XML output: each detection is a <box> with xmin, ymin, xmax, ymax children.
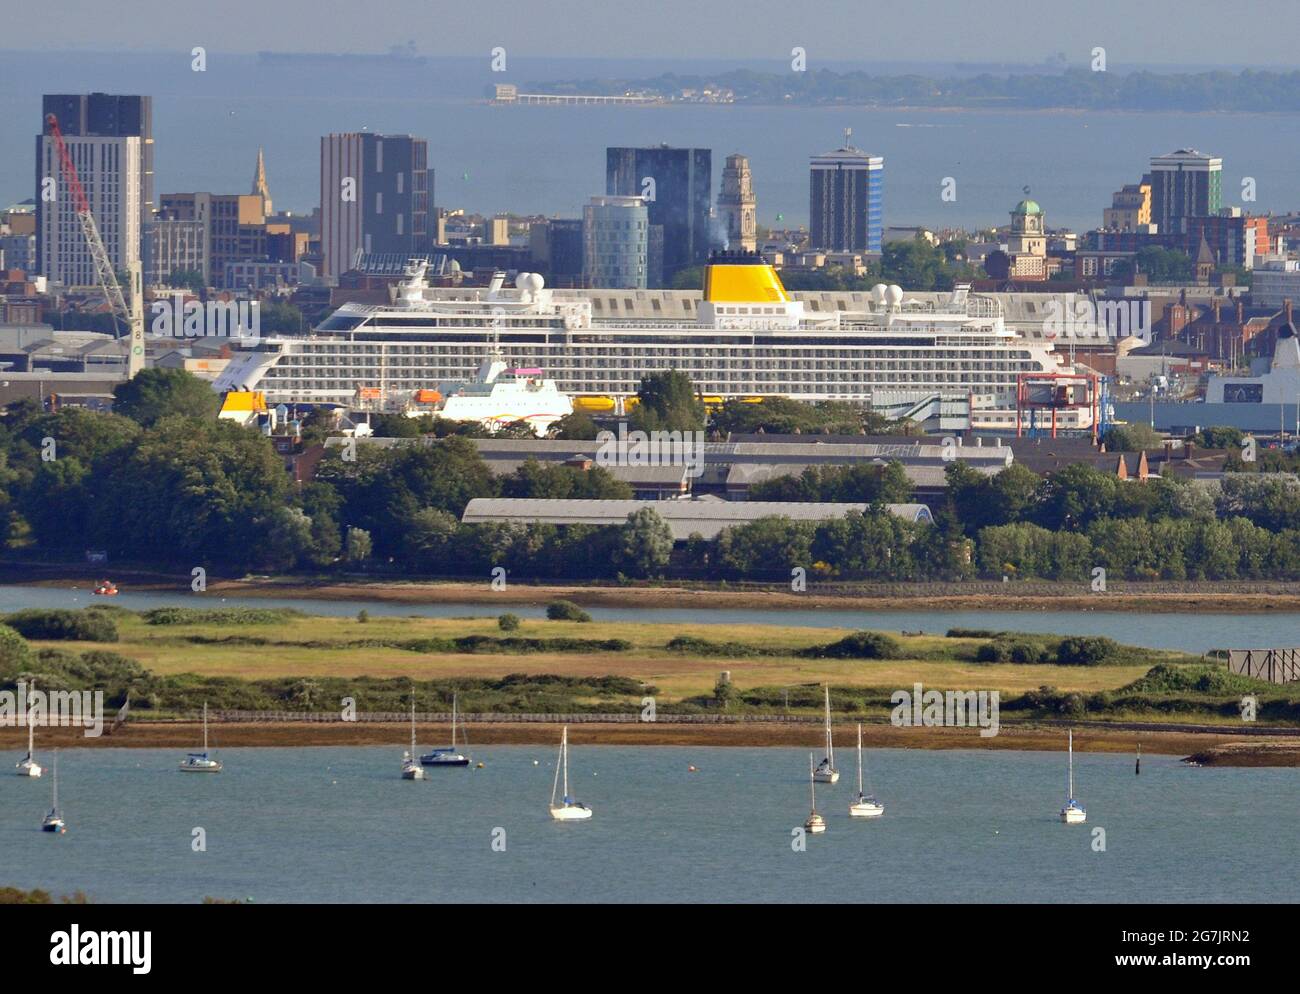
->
<box><xmin>0</xmin><ymin>743</ymin><xmax>1300</xmax><ymax>903</ymax></box>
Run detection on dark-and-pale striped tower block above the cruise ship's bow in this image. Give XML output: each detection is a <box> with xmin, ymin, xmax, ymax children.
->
<box><xmin>321</xmin><ymin>131</ymin><xmax>433</xmax><ymax>277</ymax></box>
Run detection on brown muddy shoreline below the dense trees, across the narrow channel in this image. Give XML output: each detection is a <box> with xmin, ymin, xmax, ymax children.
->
<box><xmin>0</xmin><ymin>563</ymin><xmax>1300</xmax><ymax>613</ymax></box>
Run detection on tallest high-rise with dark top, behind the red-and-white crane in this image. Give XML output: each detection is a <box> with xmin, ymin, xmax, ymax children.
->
<box><xmin>36</xmin><ymin>94</ymin><xmax>155</xmax><ymax>286</ymax></box>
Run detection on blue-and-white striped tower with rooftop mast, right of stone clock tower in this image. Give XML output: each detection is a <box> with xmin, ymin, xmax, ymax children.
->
<box><xmin>809</xmin><ymin>129</ymin><xmax>885</xmax><ymax>252</ymax></box>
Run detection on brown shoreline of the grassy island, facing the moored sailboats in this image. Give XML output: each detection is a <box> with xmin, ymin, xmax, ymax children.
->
<box><xmin>0</xmin><ymin>721</ymin><xmax>1300</xmax><ymax>767</ymax></box>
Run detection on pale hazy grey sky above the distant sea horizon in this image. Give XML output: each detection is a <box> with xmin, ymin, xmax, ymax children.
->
<box><xmin>15</xmin><ymin>0</ymin><xmax>1300</xmax><ymax>68</ymax></box>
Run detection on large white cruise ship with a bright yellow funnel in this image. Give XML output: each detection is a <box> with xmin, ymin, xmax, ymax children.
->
<box><xmin>215</xmin><ymin>253</ymin><xmax>1092</xmax><ymax>430</ymax></box>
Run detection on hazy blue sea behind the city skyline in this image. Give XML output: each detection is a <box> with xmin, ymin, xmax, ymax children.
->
<box><xmin>0</xmin><ymin>51</ymin><xmax>1300</xmax><ymax>229</ymax></box>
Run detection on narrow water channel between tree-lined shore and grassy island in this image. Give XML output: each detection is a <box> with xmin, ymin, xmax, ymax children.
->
<box><xmin>0</xmin><ymin>586</ymin><xmax>1300</xmax><ymax>652</ymax></box>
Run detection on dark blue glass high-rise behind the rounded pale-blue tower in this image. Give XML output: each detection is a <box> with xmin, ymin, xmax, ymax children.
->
<box><xmin>605</xmin><ymin>144</ymin><xmax>716</xmax><ymax>285</ymax></box>
